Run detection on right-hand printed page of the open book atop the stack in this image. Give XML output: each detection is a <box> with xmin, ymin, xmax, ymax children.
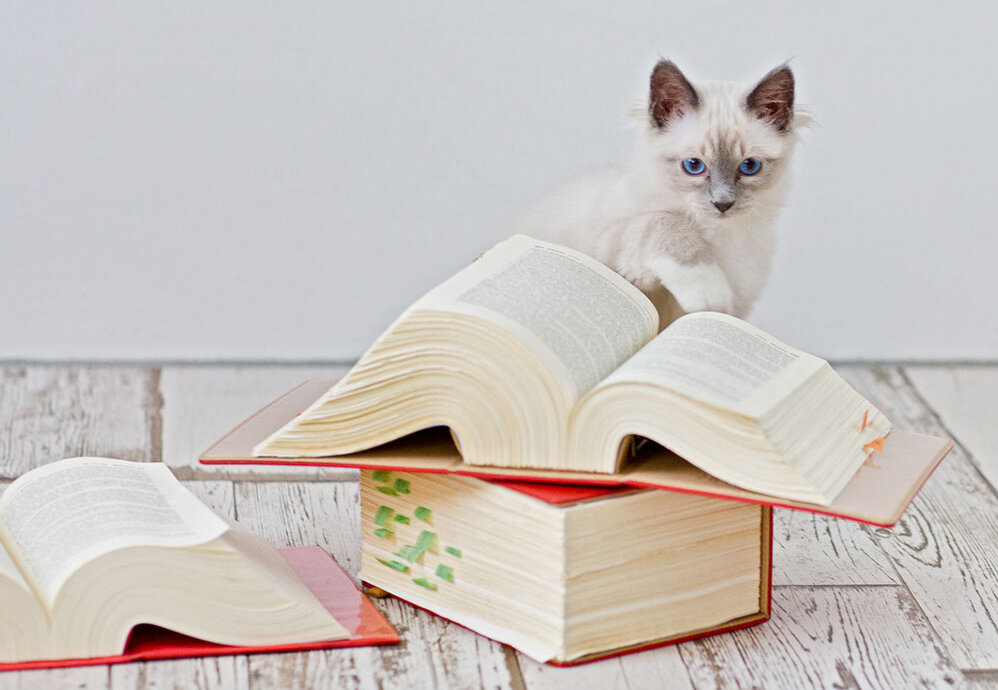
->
<box><xmin>605</xmin><ymin>312</ymin><xmax>826</xmax><ymax>418</ymax></box>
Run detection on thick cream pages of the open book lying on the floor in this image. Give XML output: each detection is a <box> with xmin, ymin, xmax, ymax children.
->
<box><xmin>0</xmin><ymin>458</ymin><xmax>397</xmax><ymax>665</ymax></box>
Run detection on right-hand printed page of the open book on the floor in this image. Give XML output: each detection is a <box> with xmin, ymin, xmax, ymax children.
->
<box><xmin>0</xmin><ymin>458</ymin><xmax>228</xmax><ymax>609</ymax></box>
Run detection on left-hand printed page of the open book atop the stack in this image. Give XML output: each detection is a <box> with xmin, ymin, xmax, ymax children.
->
<box><xmin>413</xmin><ymin>235</ymin><xmax>658</xmax><ymax>401</ymax></box>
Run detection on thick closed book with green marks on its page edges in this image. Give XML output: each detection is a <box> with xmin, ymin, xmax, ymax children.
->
<box><xmin>361</xmin><ymin>470</ymin><xmax>772</xmax><ymax>664</ymax></box>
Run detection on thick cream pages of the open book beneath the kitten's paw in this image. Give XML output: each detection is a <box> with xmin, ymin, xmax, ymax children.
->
<box><xmin>253</xmin><ymin>235</ymin><xmax>890</xmax><ymax>505</ymax></box>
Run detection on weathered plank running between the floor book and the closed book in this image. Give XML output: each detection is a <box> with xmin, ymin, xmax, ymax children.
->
<box><xmin>236</xmin><ymin>482</ymin><xmax>512</xmax><ymax>688</ymax></box>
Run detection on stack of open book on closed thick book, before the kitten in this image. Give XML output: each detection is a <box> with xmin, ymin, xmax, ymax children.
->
<box><xmin>201</xmin><ymin>236</ymin><xmax>951</xmax><ymax>664</ymax></box>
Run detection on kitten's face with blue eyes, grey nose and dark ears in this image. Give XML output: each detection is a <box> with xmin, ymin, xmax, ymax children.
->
<box><xmin>644</xmin><ymin>60</ymin><xmax>796</xmax><ymax>225</ymax></box>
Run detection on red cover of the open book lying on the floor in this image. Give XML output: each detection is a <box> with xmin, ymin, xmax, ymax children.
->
<box><xmin>0</xmin><ymin>546</ymin><xmax>400</xmax><ymax>671</ymax></box>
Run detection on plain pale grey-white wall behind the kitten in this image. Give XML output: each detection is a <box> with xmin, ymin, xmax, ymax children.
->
<box><xmin>0</xmin><ymin>0</ymin><xmax>998</xmax><ymax>360</ymax></box>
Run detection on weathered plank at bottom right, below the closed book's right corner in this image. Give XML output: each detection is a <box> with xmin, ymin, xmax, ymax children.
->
<box><xmin>679</xmin><ymin>586</ymin><xmax>962</xmax><ymax>690</ymax></box>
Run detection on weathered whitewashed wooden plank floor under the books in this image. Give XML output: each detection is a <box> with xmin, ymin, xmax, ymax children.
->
<box><xmin>0</xmin><ymin>365</ymin><xmax>998</xmax><ymax>690</ymax></box>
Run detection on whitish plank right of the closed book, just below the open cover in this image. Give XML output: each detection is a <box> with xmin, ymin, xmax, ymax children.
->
<box><xmin>773</xmin><ymin>508</ymin><xmax>900</xmax><ymax>585</ymax></box>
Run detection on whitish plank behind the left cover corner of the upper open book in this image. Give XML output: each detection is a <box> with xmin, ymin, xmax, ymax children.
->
<box><xmin>159</xmin><ymin>366</ymin><xmax>357</xmax><ymax>480</ymax></box>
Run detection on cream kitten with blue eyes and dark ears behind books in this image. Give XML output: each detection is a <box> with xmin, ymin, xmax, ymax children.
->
<box><xmin>517</xmin><ymin>60</ymin><xmax>806</xmax><ymax>328</ymax></box>
